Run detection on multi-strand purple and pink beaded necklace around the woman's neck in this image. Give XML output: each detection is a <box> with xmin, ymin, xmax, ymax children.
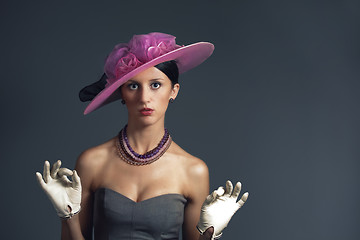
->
<box><xmin>116</xmin><ymin>125</ymin><xmax>171</xmax><ymax>166</ymax></box>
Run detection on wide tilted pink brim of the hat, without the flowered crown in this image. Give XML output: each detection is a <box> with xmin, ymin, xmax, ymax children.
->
<box><xmin>84</xmin><ymin>42</ymin><xmax>214</xmax><ymax>115</ymax></box>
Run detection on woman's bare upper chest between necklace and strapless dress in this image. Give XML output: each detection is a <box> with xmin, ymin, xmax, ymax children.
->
<box><xmin>96</xmin><ymin>151</ymin><xmax>188</xmax><ymax>202</ymax></box>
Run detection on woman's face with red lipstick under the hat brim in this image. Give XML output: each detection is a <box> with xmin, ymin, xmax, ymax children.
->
<box><xmin>121</xmin><ymin>67</ymin><xmax>180</xmax><ymax>125</ymax></box>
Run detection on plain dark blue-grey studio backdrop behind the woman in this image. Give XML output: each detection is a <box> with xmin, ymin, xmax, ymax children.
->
<box><xmin>0</xmin><ymin>0</ymin><xmax>360</xmax><ymax>240</ymax></box>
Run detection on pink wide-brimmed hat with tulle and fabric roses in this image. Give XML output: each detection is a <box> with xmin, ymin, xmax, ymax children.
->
<box><xmin>84</xmin><ymin>33</ymin><xmax>214</xmax><ymax>115</ymax></box>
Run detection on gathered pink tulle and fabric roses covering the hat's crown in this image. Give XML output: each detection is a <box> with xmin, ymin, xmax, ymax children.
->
<box><xmin>104</xmin><ymin>32</ymin><xmax>181</xmax><ymax>86</ymax></box>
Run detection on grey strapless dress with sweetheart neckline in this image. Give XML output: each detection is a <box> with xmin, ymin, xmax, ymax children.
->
<box><xmin>93</xmin><ymin>188</ymin><xmax>186</xmax><ymax>240</ymax></box>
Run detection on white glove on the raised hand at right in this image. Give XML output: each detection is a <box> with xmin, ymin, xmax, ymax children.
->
<box><xmin>197</xmin><ymin>181</ymin><xmax>249</xmax><ymax>239</ymax></box>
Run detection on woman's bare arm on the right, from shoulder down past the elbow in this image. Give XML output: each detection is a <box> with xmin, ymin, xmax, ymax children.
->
<box><xmin>183</xmin><ymin>159</ymin><xmax>211</xmax><ymax>240</ymax></box>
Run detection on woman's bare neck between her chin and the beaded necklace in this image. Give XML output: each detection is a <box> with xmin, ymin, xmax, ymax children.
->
<box><xmin>126</xmin><ymin>122</ymin><xmax>165</xmax><ymax>154</ymax></box>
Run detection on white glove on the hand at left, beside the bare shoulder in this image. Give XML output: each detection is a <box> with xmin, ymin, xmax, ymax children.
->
<box><xmin>36</xmin><ymin>160</ymin><xmax>81</xmax><ymax>218</ymax></box>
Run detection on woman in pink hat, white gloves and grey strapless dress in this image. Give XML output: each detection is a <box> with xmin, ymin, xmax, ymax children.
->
<box><xmin>37</xmin><ymin>33</ymin><xmax>248</xmax><ymax>239</ymax></box>
